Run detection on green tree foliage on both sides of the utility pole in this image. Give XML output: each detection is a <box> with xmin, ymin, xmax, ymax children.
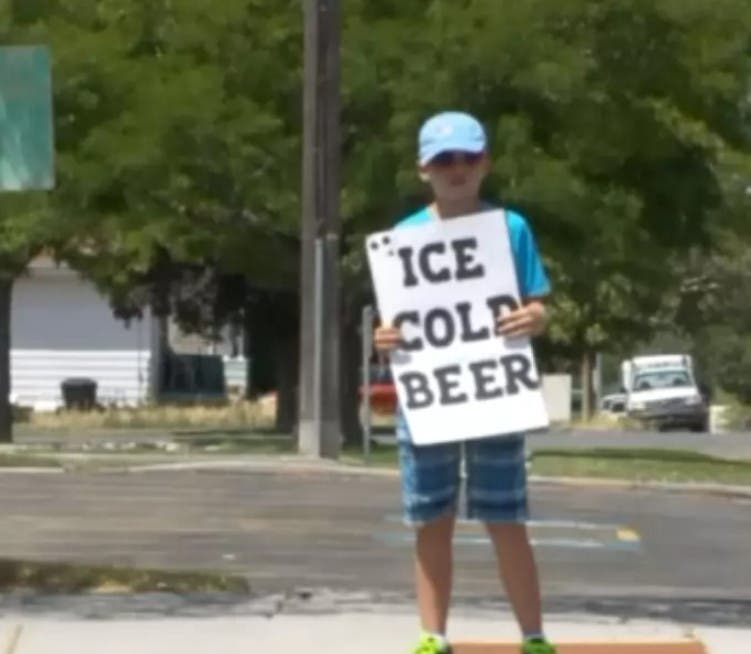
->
<box><xmin>0</xmin><ymin>0</ymin><xmax>751</xmax><ymax>368</ymax></box>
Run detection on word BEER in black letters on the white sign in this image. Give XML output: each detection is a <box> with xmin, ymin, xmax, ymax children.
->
<box><xmin>398</xmin><ymin>354</ymin><xmax>540</xmax><ymax>409</ymax></box>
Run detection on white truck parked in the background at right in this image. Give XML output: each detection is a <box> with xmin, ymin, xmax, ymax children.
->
<box><xmin>621</xmin><ymin>354</ymin><xmax>709</xmax><ymax>431</ymax></box>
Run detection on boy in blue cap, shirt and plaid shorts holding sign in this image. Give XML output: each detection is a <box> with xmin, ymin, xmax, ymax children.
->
<box><xmin>375</xmin><ymin>112</ymin><xmax>555</xmax><ymax>654</ymax></box>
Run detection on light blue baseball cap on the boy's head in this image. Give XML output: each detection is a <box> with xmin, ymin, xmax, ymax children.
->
<box><xmin>419</xmin><ymin>111</ymin><xmax>487</xmax><ymax>165</ymax></box>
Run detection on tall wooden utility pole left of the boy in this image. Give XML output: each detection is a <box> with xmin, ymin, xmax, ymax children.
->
<box><xmin>298</xmin><ymin>0</ymin><xmax>341</xmax><ymax>459</ymax></box>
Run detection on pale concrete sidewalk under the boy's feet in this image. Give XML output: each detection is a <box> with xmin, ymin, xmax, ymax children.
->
<box><xmin>0</xmin><ymin>609</ymin><xmax>751</xmax><ymax>654</ymax></box>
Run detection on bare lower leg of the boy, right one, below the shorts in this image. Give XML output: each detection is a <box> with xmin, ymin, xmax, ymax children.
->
<box><xmin>487</xmin><ymin>523</ymin><xmax>542</xmax><ymax>635</ymax></box>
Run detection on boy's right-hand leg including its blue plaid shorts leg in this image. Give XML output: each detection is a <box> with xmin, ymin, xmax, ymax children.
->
<box><xmin>467</xmin><ymin>435</ymin><xmax>542</xmax><ymax>636</ymax></box>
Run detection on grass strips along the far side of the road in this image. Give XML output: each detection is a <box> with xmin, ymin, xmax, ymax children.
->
<box><xmin>7</xmin><ymin>412</ymin><xmax>751</xmax><ymax>485</ymax></box>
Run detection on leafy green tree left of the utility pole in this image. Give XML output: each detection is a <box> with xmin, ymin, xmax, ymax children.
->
<box><xmin>19</xmin><ymin>0</ymin><xmax>301</xmax><ymax>430</ymax></box>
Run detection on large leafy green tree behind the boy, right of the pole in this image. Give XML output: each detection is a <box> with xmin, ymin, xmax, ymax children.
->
<box><xmin>340</xmin><ymin>0</ymin><xmax>751</xmax><ymax>420</ymax></box>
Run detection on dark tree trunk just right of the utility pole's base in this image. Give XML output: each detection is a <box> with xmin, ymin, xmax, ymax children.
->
<box><xmin>340</xmin><ymin>310</ymin><xmax>362</xmax><ymax>445</ymax></box>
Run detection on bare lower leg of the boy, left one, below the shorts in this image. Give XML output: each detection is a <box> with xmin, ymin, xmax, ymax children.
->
<box><xmin>415</xmin><ymin>513</ymin><xmax>454</xmax><ymax>634</ymax></box>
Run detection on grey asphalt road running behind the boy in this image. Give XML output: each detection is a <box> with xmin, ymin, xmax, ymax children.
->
<box><xmin>0</xmin><ymin>471</ymin><xmax>751</xmax><ymax>623</ymax></box>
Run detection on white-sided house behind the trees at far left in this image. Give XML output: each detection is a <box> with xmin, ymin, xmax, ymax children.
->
<box><xmin>10</xmin><ymin>256</ymin><xmax>152</xmax><ymax>411</ymax></box>
